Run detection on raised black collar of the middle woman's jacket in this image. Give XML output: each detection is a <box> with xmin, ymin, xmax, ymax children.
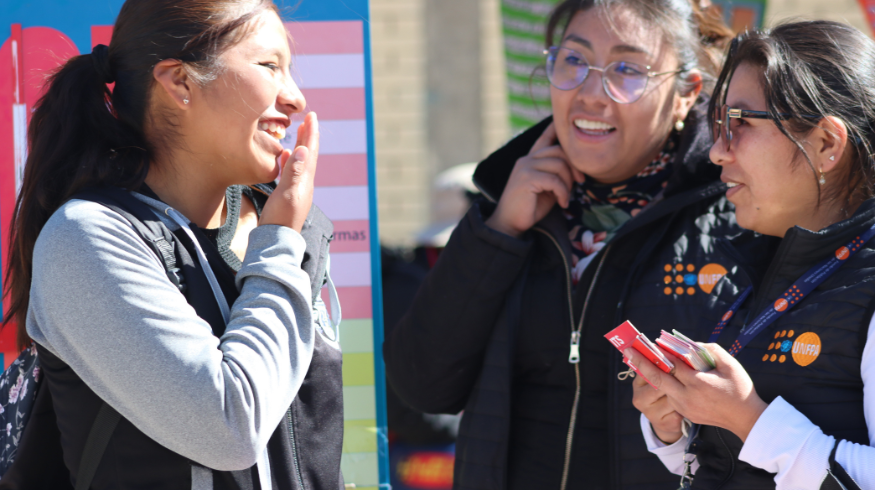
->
<box><xmin>474</xmin><ymin>97</ymin><xmax>720</xmax><ymax>202</ymax></box>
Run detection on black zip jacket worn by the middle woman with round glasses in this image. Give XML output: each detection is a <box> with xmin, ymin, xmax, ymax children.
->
<box><xmin>384</xmin><ymin>103</ymin><xmax>756</xmax><ymax>490</ymax></box>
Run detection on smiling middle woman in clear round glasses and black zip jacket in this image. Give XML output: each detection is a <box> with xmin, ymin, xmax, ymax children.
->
<box><xmin>384</xmin><ymin>0</ymin><xmax>739</xmax><ymax>489</ymax></box>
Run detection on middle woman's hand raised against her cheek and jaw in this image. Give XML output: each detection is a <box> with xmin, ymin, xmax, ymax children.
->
<box><xmin>486</xmin><ymin>124</ymin><xmax>584</xmax><ymax>236</ymax></box>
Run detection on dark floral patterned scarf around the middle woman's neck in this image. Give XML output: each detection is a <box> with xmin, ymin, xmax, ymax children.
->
<box><xmin>564</xmin><ymin>132</ymin><xmax>678</xmax><ymax>285</ymax></box>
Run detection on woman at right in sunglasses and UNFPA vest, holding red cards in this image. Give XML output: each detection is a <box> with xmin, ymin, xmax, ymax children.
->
<box><xmin>629</xmin><ymin>22</ymin><xmax>875</xmax><ymax>490</ymax></box>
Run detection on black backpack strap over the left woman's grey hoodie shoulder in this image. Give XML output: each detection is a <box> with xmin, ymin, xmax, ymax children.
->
<box><xmin>71</xmin><ymin>187</ymin><xmax>186</xmax><ymax>293</ymax></box>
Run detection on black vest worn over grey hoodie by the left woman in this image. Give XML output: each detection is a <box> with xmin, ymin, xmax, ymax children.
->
<box><xmin>37</xmin><ymin>189</ymin><xmax>343</xmax><ymax>490</ymax></box>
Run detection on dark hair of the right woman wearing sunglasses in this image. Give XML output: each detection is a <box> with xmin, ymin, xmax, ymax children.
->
<box><xmin>709</xmin><ymin>20</ymin><xmax>875</xmax><ymax>209</ymax></box>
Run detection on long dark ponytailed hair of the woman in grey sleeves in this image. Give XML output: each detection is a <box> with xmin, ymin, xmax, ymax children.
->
<box><xmin>3</xmin><ymin>0</ymin><xmax>276</xmax><ymax>348</ymax></box>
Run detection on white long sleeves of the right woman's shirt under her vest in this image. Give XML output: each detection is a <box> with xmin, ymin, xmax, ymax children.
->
<box><xmin>641</xmin><ymin>317</ymin><xmax>875</xmax><ymax>490</ymax></box>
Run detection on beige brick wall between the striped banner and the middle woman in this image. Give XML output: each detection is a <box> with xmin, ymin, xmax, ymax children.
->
<box><xmin>371</xmin><ymin>0</ymin><xmax>509</xmax><ymax>245</ymax></box>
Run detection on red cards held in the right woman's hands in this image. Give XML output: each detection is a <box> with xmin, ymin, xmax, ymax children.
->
<box><xmin>605</xmin><ymin>320</ymin><xmax>715</xmax><ymax>388</ymax></box>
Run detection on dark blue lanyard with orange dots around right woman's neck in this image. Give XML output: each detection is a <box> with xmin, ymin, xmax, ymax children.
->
<box><xmin>708</xmin><ymin>225</ymin><xmax>875</xmax><ymax>357</ymax></box>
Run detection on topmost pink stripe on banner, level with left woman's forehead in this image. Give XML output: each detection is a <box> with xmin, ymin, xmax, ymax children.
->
<box><xmin>285</xmin><ymin>20</ymin><xmax>365</xmax><ymax>54</ymax></box>
